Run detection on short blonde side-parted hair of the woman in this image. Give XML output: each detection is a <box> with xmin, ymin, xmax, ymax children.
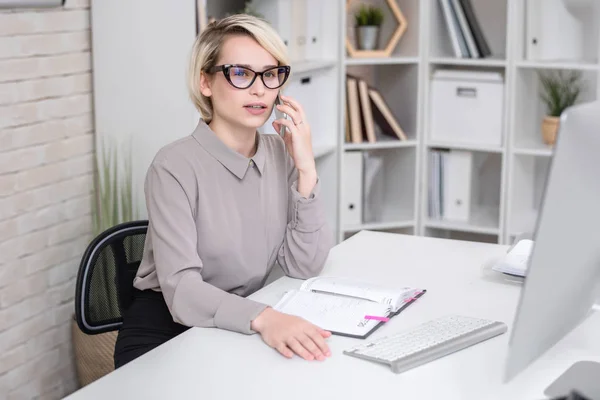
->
<box><xmin>188</xmin><ymin>14</ymin><xmax>289</xmax><ymax>123</ymax></box>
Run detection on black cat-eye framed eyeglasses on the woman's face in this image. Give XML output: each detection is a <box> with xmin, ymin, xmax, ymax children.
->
<box><xmin>208</xmin><ymin>64</ymin><xmax>290</xmax><ymax>89</ymax></box>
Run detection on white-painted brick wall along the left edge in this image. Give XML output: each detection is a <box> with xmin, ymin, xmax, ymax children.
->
<box><xmin>0</xmin><ymin>0</ymin><xmax>94</xmax><ymax>399</ymax></box>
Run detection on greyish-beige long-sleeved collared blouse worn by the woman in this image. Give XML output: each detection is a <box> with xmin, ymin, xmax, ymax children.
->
<box><xmin>134</xmin><ymin>120</ymin><xmax>333</xmax><ymax>334</ymax></box>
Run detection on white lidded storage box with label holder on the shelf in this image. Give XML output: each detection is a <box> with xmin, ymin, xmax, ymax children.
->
<box><xmin>430</xmin><ymin>70</ymin><xmax>504</xmax><ymax>146</ymax></box>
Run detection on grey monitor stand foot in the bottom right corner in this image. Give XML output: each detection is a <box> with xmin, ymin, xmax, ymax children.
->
<box><xmin>544</xmin><ymin>361</ymin><xmax>600</xmax><ymax>400</ymax></box>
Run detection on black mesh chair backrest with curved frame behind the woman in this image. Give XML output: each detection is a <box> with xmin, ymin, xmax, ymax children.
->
<box><xmin>75</xmin><ymin>220</ymin><xmax>148</xmax><ymax>334</ymax></box>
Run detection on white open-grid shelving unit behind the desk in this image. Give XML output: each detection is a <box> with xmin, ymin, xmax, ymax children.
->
<box><xmin>339</xmin><ymin>0</ymin><xmax>600</xmax><ymax>243</ymax></box>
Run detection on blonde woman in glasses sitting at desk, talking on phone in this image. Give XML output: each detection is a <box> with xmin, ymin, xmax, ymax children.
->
<box><xmin>115</xmin><ymin>15</ymin><xmax>333</xmax><ymax>367</ymax></box>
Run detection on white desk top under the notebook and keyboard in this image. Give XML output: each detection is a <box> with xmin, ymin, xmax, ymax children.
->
<box><xmin>65</xmin><ymin>232</ymin><xmax>600</xmax><ymax>400</ymax></box>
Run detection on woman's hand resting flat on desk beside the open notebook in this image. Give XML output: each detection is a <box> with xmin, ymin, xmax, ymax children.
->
<box><xmin>252</xmin><ymin>307</ymin><xmax>331</xmax><ymax>361</ymax></box>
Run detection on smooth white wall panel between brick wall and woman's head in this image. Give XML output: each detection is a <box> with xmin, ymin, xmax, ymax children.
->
<box><xmin>91</xmin><ymin>0</ymin><xmax>199</xmax><ymax>218</ymax></box>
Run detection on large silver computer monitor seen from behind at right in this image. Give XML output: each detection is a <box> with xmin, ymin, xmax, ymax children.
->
<box><xmin>505</xmin><ymin>102</ymin><xmax>600</xmax><ymax>399</ymax></box>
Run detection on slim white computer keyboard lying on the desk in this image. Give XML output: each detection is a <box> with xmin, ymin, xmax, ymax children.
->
<box><xmin>344</xmin><ymin>315</ymin><xmax>507</xmax><ymax>373</ymax></box>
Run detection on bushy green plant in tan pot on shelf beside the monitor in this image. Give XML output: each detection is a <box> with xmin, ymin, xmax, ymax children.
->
<box><xmin>538</xmin><ymin>71</ymin><xmax>582</xmax><ymax>145</ymax></box>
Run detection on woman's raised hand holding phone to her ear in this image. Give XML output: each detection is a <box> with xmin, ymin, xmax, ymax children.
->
<box><xmin>273</xmin><ymin>95</ymin><xmax>316</xmax><ymax>175</ymax></box>
